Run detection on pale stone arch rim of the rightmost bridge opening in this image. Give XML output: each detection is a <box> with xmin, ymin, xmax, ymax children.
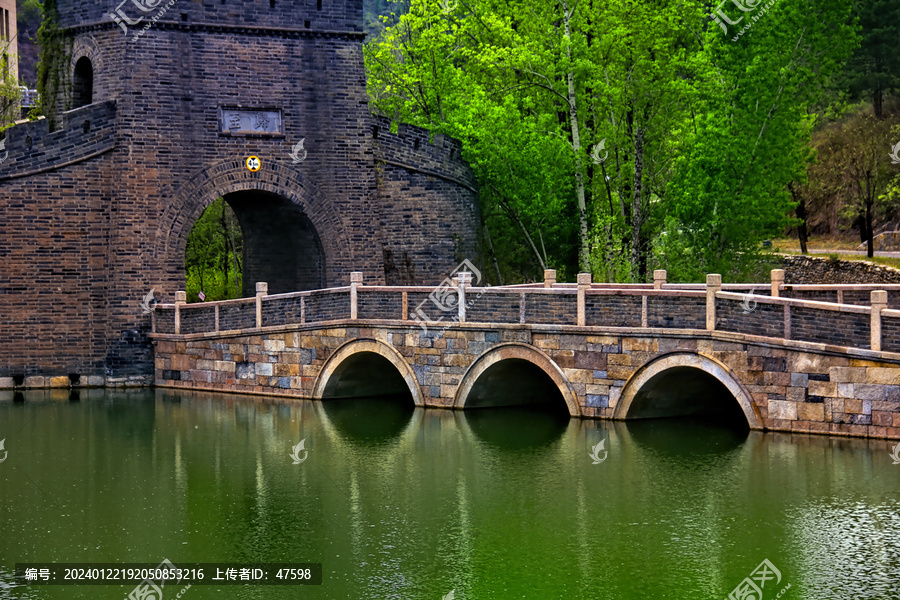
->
<box><xmin>613</xmin><ymin>352</ymin><xmax>763</xmax><ymax>429</ymax></box>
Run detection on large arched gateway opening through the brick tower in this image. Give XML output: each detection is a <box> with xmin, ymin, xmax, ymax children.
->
<box><xmin>185</xmin><ymin>190</ymin><xmax>325</xmax><ymax>302</ymax></box>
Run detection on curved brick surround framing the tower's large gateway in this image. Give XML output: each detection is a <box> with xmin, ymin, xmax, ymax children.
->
<box><xmin>153</xmin><ymin>157</ymin><xmax>352</xmax><ymax>286</ymax></box>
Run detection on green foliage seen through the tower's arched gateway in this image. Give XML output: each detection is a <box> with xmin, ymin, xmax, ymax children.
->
<box><xmin>184</xmin><ymin>198</ymin><xmax>243</xmax><ymax>302</ymax></box>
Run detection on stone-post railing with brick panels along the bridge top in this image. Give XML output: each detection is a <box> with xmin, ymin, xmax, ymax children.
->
<box><xmin>152</xmin><ymin>270</ymin><xmax>900</xmax><ymax>352</ymax></box>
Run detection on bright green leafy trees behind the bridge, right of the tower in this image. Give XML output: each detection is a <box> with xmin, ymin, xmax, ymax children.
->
<box><xmin>365</xmin><ymin>0</ymin><xmax>857</xmax><ymax>282</ymax></box>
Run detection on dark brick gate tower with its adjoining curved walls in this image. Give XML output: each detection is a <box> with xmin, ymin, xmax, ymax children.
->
<box><xmin>0</xmin><ymin>0</ymin><xmax>479</xmax><ymax>386</ymax></box>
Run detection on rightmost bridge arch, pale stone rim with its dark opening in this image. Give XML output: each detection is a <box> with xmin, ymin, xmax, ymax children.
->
<box><xmin>615</xmin><ymin>353</ymin><xmax>762</xmax><ymax>430</ymax></box>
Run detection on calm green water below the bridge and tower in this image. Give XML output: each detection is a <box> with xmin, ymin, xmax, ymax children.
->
<box><xmin>0</xmin><ymin>391</ymin><xmax>900</xmax><ymax>600</ymax></box>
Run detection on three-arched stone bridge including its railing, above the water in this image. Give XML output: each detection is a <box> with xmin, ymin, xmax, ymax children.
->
<box><xmin>152</xmin><ymin>271</ymin><xmax>900</xmax><ymax>439</ymax></box>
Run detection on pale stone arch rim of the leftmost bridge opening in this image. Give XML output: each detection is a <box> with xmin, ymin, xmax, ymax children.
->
<box><xmin>313</xmin><ymin>339</ymin><xmax>425</xmax><ymax>406</ymax></box>
